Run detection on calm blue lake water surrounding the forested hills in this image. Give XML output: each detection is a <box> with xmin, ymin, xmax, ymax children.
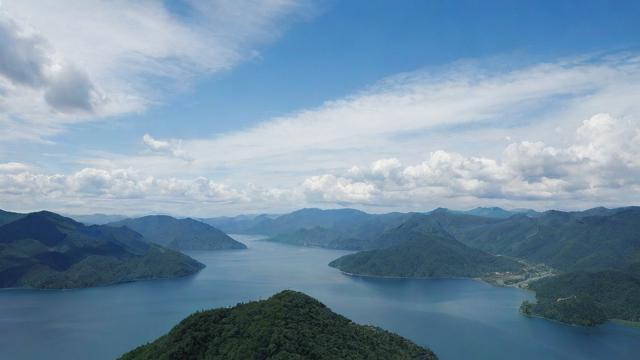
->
<box><xmin>0</xmin><ymin>236</ymin><xmax>640</xmax><ymax>360</ymax></box>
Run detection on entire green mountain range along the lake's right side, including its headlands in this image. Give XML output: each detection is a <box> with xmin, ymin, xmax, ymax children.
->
<box><xmin>209</xmin><ymin>207</ymin><xmax>640</xmax><ymax>325</ymax></box>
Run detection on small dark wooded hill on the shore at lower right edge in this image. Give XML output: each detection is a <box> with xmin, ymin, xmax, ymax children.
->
<box><xmin>521</xmin><ymin>271</ymin><xmax>640</xmax><ymax>326</ymax></box>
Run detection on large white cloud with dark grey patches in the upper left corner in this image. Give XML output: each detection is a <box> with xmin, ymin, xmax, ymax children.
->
<box><xmin>0</xmin><ymin>0</ymin><xmax>308</xmax><ymax>140</ymax></box>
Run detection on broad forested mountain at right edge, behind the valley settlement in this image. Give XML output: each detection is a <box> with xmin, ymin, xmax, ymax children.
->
<box><xmin>445</xmin><ymin>207</ymin><xmax>640</xmax><ymax>272</ymax></box>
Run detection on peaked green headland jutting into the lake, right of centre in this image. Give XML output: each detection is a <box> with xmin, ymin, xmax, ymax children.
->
<box><xmin>329</xmin><ymin>216</ymin><xmax>522</xmax><ymax>278</ymax></box>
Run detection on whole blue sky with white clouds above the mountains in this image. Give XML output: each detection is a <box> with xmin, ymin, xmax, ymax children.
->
<box><xmin>0</xmin><ymin>0</ymin><xmax>640</xmax><ymax>217</ymax></box>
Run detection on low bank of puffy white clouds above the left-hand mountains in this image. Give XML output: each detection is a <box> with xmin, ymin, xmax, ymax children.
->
<box><xmin>0</xmin><ymin>165</ymin><xmax>282</xmax><ymax>215</ymax></box>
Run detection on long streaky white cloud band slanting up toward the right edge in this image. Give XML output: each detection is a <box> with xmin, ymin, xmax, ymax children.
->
<box><xmin>96</xmin><ymin>56</ymin><xmax>640</xmax><ymax>179</ymax></box>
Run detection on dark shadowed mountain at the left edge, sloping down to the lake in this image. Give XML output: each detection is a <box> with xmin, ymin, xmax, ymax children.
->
<box><xmin>0</xmin><ymin>211</ymin><xmax>204</xmax><ymax>289</ymax></box>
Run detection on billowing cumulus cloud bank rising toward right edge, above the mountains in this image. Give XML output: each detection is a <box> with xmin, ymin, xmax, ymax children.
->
<box><xmin>303</xmin><ymin>114</ymin><xmax>640</xmax><ymax>210</ymax></box>
